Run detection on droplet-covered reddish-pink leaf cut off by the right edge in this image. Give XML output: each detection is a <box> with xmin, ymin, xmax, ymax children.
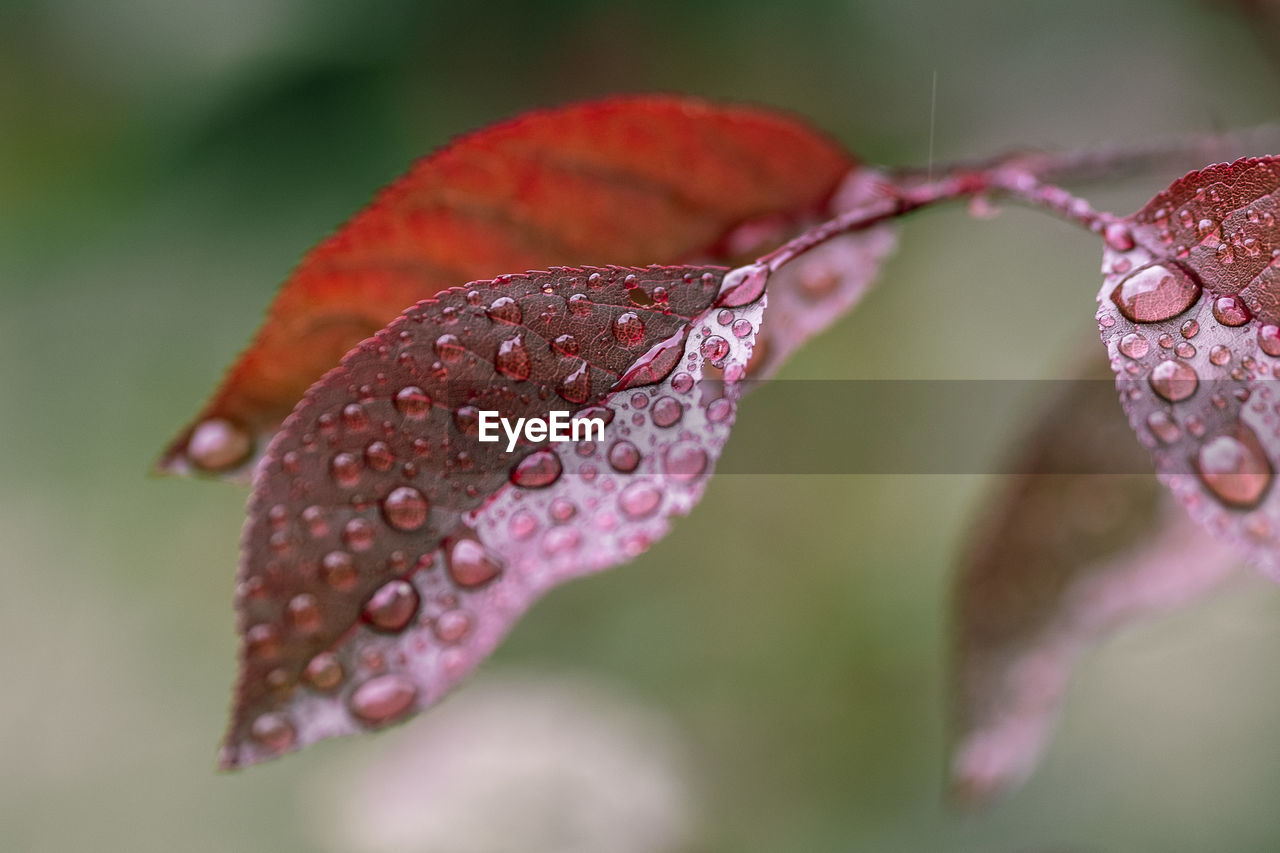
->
<box><xmin>1097</xmin><ymin>158</ymin><xmax>1280</xmax><ymax>579</ymax></box>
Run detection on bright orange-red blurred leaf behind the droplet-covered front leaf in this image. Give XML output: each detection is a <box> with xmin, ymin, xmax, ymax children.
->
<box><xmin>159</xmin><ymin>96</ymin><xmax>870</xmax><ymax>479</ymax></box>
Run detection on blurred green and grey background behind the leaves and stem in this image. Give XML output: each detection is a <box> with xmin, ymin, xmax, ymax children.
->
<box><xmin>0</xmin><ymin>0</ymin><xmax>1280</xmax><ymax>853</ymax></box>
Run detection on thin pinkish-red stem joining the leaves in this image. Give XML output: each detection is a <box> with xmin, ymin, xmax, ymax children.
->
<box><xmin>756</xmin><ymin>124</ymin><xmax>1280</xmax><ymax>272</ymax></box>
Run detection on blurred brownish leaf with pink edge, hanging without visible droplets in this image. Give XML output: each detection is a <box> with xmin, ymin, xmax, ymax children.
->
<box><xmin>951</xmin><ymin>353</ymin><xmax>1239</xmax><ymax>804</ymax></box>
